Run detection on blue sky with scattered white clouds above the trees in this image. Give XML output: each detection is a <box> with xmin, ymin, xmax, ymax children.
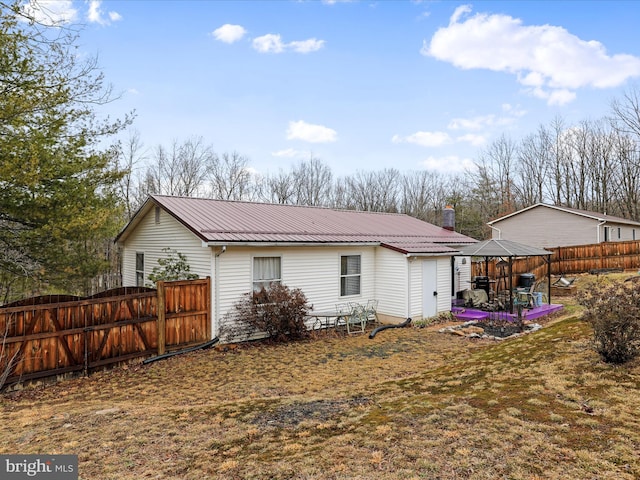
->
<box><xmin>25</xmin><ymin>0</ymin><xmax>640</xmax><ymax>175</ymax></box>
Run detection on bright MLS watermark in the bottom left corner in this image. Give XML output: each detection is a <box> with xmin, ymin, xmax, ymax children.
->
<box><xmin>0</xmin><ymin>455</ymin><xmax>78</xmax><ymax>480</ymax></box>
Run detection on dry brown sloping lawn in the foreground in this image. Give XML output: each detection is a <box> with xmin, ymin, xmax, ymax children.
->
<box><xmin>0</xmin><ymin>275</ymin><xmax>640</xmax><ymax>480</ymax></box>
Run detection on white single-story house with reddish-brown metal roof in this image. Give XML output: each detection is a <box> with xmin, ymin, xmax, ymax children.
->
<box><xmin>116</xmin><ymin>195</ymin><xmax>476</xmax><ymax>337</ymax></box>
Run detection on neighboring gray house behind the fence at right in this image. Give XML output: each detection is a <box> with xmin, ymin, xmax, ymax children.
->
<box><xmin>487</xmin><ymin>203</ymin><xmax>640</xmax><ymax>248</ymax></box>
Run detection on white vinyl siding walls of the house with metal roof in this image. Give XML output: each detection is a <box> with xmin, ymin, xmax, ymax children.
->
<box><xmin>122</xmin><ymin>204</ymin><xmax>466</xmax><ymax>336</ymax></box>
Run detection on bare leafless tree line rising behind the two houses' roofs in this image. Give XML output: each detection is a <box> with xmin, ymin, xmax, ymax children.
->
<box><xmin>119</xmin><ymin>101</ymin><xmax>640</xmax><ymax>239</ymax></box>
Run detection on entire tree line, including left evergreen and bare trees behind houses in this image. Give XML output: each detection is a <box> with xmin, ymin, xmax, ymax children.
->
<box><xmin>0</xmin><ymin>0</ymin><xmax>640</xmax><ymax>303</ymax></box>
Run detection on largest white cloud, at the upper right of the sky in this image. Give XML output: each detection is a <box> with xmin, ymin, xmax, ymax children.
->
<box><xmin>421</xmin><ymin>5</ymin><xmax>640</xmax><ymax>105</ymax></box>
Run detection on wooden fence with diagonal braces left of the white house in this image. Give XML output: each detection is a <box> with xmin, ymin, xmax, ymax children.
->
<box><xmin>0</xmin><ymin>278</ymin><xmax>211</xmax><ymax>387</ymax></box>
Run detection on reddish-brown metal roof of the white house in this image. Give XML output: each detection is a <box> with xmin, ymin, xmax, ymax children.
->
<box><xmin>116</xmin><ymin>195</ymin><xmax>476</xmax><ymax>254</ymax></box>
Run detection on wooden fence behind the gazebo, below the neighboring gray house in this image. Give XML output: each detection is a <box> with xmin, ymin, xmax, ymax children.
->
<box><xmin>471</xmin><ymin>240</ymin><xmax>640</xmax><ymax>285</ymax></box>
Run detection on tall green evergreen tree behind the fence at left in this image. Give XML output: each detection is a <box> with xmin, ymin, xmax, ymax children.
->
<box><xmin>0</xmin><ymin>2</ymin><xmax>129</xmax><ymax>297</ymax></box>
